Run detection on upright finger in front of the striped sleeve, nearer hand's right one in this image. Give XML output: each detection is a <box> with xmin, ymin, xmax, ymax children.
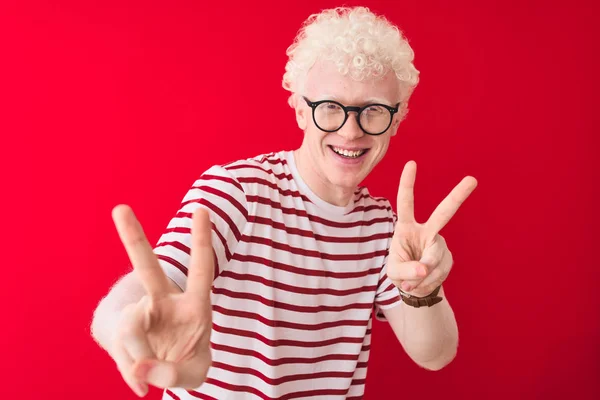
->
<box><xmin>186</xmin><ymin>208</ymin><xmax>214</xmax><ymax>299</ymax></box>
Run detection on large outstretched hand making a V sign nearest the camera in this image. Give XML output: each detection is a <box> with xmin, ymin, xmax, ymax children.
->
<box><xmin>109</xmin><ymin>206</ymin><xmax>214</xmax><ymax>397</ymax></box>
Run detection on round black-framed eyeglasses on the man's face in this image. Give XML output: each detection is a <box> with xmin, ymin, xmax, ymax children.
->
<box><xmin>303</xmin><ymin>97</ymin><xmax>400</xmax><ymax>136</ymax></box>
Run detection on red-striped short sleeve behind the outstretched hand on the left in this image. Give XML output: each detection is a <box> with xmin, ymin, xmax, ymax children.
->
<box><xmin>154</xmin><ymin>166</ymin><xmax>248</xmax><ymax>290</ymax></box>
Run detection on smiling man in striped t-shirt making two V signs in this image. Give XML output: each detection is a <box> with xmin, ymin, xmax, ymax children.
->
<box><xmin>92</xmin><ymin>4</ymin><xmax>477</xmax><ymax>399</ymax></box>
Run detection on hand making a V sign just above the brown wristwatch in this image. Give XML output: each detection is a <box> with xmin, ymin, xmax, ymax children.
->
<box><xmin>387</xmin><ymin>161</ymin><xmax>477</xmax><ymax>297</ymax></box>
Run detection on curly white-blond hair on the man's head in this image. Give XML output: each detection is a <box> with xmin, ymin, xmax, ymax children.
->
<box><xmin>283</xmin><ymin>7</ymin><xmax>419</xmax><ymax>119</ymax></box>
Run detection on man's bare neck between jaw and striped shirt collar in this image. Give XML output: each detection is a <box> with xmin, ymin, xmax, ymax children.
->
<box><xmin>294</xmin><ymin>146</ymin><xmax>356</xmax><ymax>207</ymax></box>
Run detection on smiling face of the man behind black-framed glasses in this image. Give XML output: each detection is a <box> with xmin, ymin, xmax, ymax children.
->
<box><xmin>296</xmin><ymin>61</ymin><xmax>400</xmax><ymax>195</ymax></box>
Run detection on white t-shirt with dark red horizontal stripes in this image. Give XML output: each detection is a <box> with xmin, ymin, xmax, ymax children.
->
<box><xmin>154</xmin><ymin>151</ymin><xmax>400</xmax><ymax>400</ymax></box>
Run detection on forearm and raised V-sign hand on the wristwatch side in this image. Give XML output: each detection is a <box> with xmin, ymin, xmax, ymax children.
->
<box><xmin>379</xmin><ymin>161</ymin><xmax>477</xmax><ymax>370</ymax></box>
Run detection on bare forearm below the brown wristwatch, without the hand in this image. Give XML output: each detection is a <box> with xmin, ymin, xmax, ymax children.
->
<box><xmin>382</xmin><ymin>287</ymin><xmax>458</xmax><ymax>371</ymax></box>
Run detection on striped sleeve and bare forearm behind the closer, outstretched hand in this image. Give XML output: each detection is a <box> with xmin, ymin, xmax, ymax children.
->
<box><xmin>91</xmin><ymin>167</ymin><xmax>247</xmax><ymax>353</ymax></box>
